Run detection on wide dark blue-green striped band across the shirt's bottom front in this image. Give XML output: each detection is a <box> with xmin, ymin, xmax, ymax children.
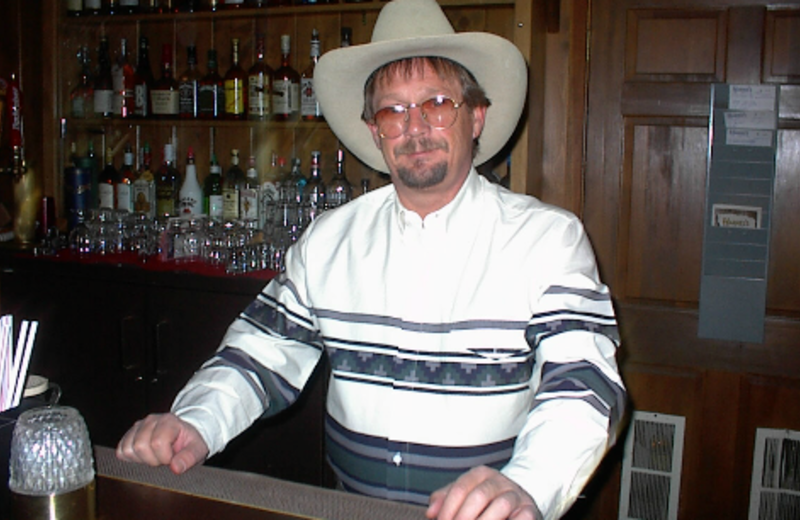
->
<box><xmin>325</xmin><ymin>417</ymin><xmax>514</xmax><ymax>504</ymax></box>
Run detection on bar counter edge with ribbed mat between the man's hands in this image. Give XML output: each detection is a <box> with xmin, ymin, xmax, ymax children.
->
<box><xmin>95</xmin><ymin>446</ymin><xmax>425</xmax><ymax>520</ymax></box>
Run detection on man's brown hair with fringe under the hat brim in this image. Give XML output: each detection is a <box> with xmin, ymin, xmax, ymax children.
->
<box><xmin>361</xmin><ymin>56</ymin><xmax>492</xmax><ymax>122</ymax></box>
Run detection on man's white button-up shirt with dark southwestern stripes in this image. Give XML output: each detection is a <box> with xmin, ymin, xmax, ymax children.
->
<box><xmin>173</xmin><ymin>170</ymin><xmax>625</xmax><ymax>518</ymax></box>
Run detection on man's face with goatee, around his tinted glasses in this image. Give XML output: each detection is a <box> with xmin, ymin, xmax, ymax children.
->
<box><xmin>369</xmin><ymin>64</ymin><xmax>486</xmax><ymax>205</ymax></box>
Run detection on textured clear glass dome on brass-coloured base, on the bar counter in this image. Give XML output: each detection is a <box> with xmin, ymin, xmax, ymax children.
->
<box><xmin>8</xmin><ymin>406</ymin><xmax>96</xmax><ymax>520</ymax></box>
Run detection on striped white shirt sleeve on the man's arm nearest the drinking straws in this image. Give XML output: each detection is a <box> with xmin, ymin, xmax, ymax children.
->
<box><xmin>172</xmin><ymin>234</ymin><xmax>322</xmax><ymax>455</ymax></box>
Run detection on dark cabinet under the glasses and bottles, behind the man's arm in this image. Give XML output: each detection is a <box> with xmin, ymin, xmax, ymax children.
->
<box><xmin>0</xmin><ymin>259</ymin><xmax>331</xmax><ymax>485</ymax></box>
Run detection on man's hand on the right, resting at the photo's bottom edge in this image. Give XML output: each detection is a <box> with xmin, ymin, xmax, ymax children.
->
<box><xmin>426</xmin><ymin>466</ymin><xmax>541</xmax><ymax>520</ymax></box>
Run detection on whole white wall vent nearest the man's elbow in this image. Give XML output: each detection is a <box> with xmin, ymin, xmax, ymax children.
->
<box><xmin>619</xmin><ymin>411</ymin><xmax>686</xmax><ymax>520</ymax></box>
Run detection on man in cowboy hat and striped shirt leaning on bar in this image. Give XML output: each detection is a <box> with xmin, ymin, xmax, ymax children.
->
<box><xmin>118</xmin><ymin>0</ymin><xmax>625</xmax><ymax>520</ymax></box>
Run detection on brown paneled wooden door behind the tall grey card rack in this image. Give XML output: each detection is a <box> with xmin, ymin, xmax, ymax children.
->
<box><xmin>581</xmin><ymin>0</ymin><xmax>800</xmax><ymax>519</ymax></box>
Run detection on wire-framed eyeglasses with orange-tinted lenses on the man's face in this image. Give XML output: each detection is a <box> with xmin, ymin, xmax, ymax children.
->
<box><xmin>372</xmin><ymin>95</ymin><xmax>463</xmax><ymax>139</ymax></box>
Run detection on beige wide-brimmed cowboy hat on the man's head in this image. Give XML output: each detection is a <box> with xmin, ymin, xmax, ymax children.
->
<box><xmin>314</xmin><ymin>0</ymin><xmax>528</xmax><ymax>172</ymax></box>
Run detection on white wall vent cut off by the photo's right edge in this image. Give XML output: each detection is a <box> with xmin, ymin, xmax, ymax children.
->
<box><xmin>748</xmin><ymin>428</ymin><xmax>800</xmax><ymax>520</ymax></box>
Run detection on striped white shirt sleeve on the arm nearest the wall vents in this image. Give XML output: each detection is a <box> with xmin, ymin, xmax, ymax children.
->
<box><xmin>502</xmin><ymin>214</ymin><xmax>626</xmax><ymax>520</ymax></box>
